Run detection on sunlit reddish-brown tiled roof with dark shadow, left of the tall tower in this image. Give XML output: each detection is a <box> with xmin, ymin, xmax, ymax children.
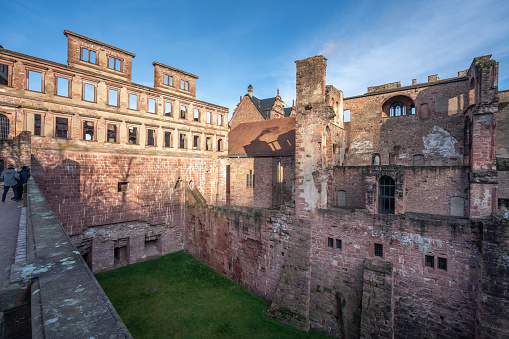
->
<box><xmin>228</xmin><ymin>117</ymin><xmax>295</xmax><ymax>157</ymax></box>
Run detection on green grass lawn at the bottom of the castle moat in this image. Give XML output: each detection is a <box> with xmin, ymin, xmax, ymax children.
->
<box><xmin>96</xmin><ymin>252</ymin><xmax>326</xmax><ymax>338</ymax></box>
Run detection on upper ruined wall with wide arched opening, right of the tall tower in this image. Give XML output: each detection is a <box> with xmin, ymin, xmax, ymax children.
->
<box><xmin>344</xmin><ymin>80</ymin><xmax>469</xmax><ymax>166</ymax></box>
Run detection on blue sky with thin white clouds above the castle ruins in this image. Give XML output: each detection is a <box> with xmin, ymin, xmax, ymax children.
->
<box><xmin>0</xmin><ymin>0</ymin><xmax>509</xmax><ymax>120</ymax></box>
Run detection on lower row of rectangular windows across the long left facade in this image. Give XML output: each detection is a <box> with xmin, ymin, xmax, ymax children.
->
<box><xmin>18</xmin><ymin>114</ymin><xmax>224</xmax><ymax>152</ymax></box>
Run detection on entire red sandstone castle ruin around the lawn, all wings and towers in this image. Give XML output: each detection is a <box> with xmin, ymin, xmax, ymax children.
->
<box><xmin>0</xmin><ymin>31</ymin><xmax>509</xmax><ymax>338</ymax></box>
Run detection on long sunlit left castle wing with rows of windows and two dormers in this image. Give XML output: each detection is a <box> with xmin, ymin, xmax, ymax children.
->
<box><xmin>0</xmin><ymin>31</ymin><xmax>228</xmax><ymax>272</ymax></box>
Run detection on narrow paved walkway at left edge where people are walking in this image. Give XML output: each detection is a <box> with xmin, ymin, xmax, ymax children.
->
<box><xmin>0</xmin><ymin>190</ymin><xmax>26</xmax><ymax>282</ymax></box>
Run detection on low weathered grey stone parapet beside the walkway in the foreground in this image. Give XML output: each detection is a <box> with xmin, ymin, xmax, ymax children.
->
<box><xmin>0</xmin><ymin>179</ymin><xmax>131</xmax><ymax>338</ymax></box>
